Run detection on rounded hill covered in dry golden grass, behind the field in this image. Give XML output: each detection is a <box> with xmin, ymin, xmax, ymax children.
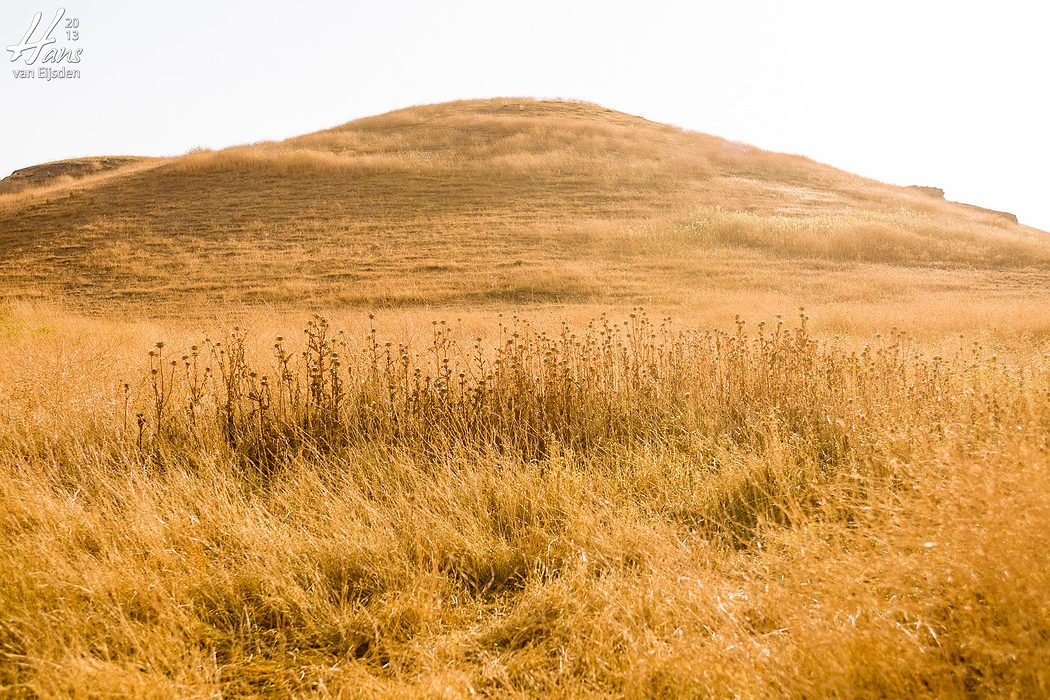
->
<box><xmin>0</xmin><ymin>100</ymin><xmax>1050</xmax><ymax>313</ymax></box>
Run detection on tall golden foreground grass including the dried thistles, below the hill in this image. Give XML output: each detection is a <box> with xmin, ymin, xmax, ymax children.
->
<box><xmin>0</xmin><ymin>310</ymin><xmax>1050</xmax><ymax>697</ymax></box>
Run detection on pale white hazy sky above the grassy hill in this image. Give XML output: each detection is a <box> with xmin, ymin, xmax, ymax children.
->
<box><xmin>0</xmin><ymin>0</ymin><xmax>1050</xmax><ymax>230</ymax></box>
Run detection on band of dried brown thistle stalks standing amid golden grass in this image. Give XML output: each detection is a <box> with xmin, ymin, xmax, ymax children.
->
<box><xmin>133</xmin><ymin>311</ymin><xmax>919</xmax><ymax>482</ymax></box>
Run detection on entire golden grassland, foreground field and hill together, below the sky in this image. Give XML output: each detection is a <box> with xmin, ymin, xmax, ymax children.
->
<box><xmin>0</xmin><ymin>100</ymin><xmax>1050</xmax><ymax>698</ymax></box>
